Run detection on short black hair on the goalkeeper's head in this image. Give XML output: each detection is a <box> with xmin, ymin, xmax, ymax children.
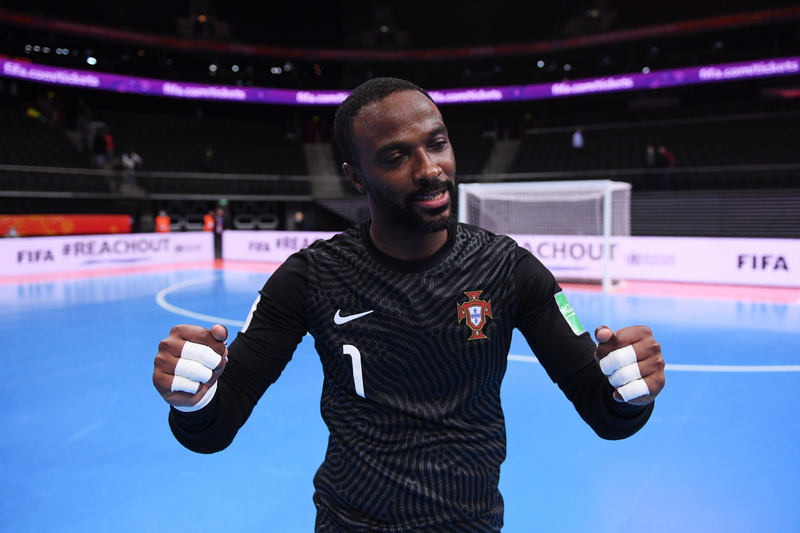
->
<box><xmin>333</xmin><ymin>78</ymin><xmax>435</xmax><ymax>166</ymax></box>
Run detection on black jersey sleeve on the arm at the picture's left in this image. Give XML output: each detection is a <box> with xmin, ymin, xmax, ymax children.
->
<box><xmin>169</xmin><ymin>252</ymin><xmax>308</xmax><ymax>453</ymax></box>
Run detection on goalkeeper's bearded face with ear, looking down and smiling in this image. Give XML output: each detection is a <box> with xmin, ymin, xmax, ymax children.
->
<box><xmin>345</xmin><ymin>91</ymin><xmax>458</xmax><ymax>233</ymax></box>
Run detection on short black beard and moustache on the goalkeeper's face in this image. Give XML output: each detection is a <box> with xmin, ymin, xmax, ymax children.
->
<box><xmin>367</xmin><ymin>180</ymin><xmax>458</xmax><ymax>233</ymax></box>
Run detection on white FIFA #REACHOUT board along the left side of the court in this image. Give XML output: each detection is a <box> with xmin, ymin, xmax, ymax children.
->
<box><xmin>0</xmin><ymin>231</ymin><xmax>214</xmax><ymax>277</ymax></box>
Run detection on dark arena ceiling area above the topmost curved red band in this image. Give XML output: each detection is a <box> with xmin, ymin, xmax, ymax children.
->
<box><xmin>6</xmin><ymin>0</ymin><xmax>797</xmax><ymax>48</ymax></box>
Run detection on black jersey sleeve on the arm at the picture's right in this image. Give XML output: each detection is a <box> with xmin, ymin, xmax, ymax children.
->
<box><xmin>514</xmin><ymin>247</ymin><xmax>654</xmax><ymax>440</ymax></box>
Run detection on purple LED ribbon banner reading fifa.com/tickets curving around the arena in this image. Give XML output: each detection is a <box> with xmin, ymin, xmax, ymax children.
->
<box><xmin>0</xmin><ymin>56</ymin><xmax>800</xmax><ymax>105</ymax></box>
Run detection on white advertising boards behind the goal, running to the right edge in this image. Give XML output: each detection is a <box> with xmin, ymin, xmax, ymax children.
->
<box><xmin>222</xmin><ymin>231</ymin><xmax>800</xmax><ymax>287</ymax></box>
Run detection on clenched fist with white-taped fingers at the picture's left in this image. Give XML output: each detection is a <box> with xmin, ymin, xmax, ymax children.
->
<box><xmin>153</xmin><ymin>324</ymin><xmax>228</xmax><ymax>407</ymax></box>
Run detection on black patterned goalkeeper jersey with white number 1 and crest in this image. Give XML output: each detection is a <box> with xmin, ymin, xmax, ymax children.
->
<box><xmin>170</xmin><ymin>222</ymin><xmax>652</xmax><ymax>532</ymax></box>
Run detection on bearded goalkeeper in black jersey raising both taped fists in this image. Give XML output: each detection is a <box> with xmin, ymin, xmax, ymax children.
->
<box><xmin>153</xmin><ymin>78</ymin><xmax>664</xmax><ymax>532</ymax></box>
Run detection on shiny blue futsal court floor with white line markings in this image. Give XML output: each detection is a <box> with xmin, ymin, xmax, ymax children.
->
<box><xmin>0</xmin><ymin>266</ymin><xmax>800</xmax><ymax>533</ymax></box>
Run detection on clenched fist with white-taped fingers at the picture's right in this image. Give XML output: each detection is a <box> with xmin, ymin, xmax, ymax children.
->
<box><xmin>594</xmin><ymin>326</ymin><xmax>665</xmax><ymax>405</ymax></box>
